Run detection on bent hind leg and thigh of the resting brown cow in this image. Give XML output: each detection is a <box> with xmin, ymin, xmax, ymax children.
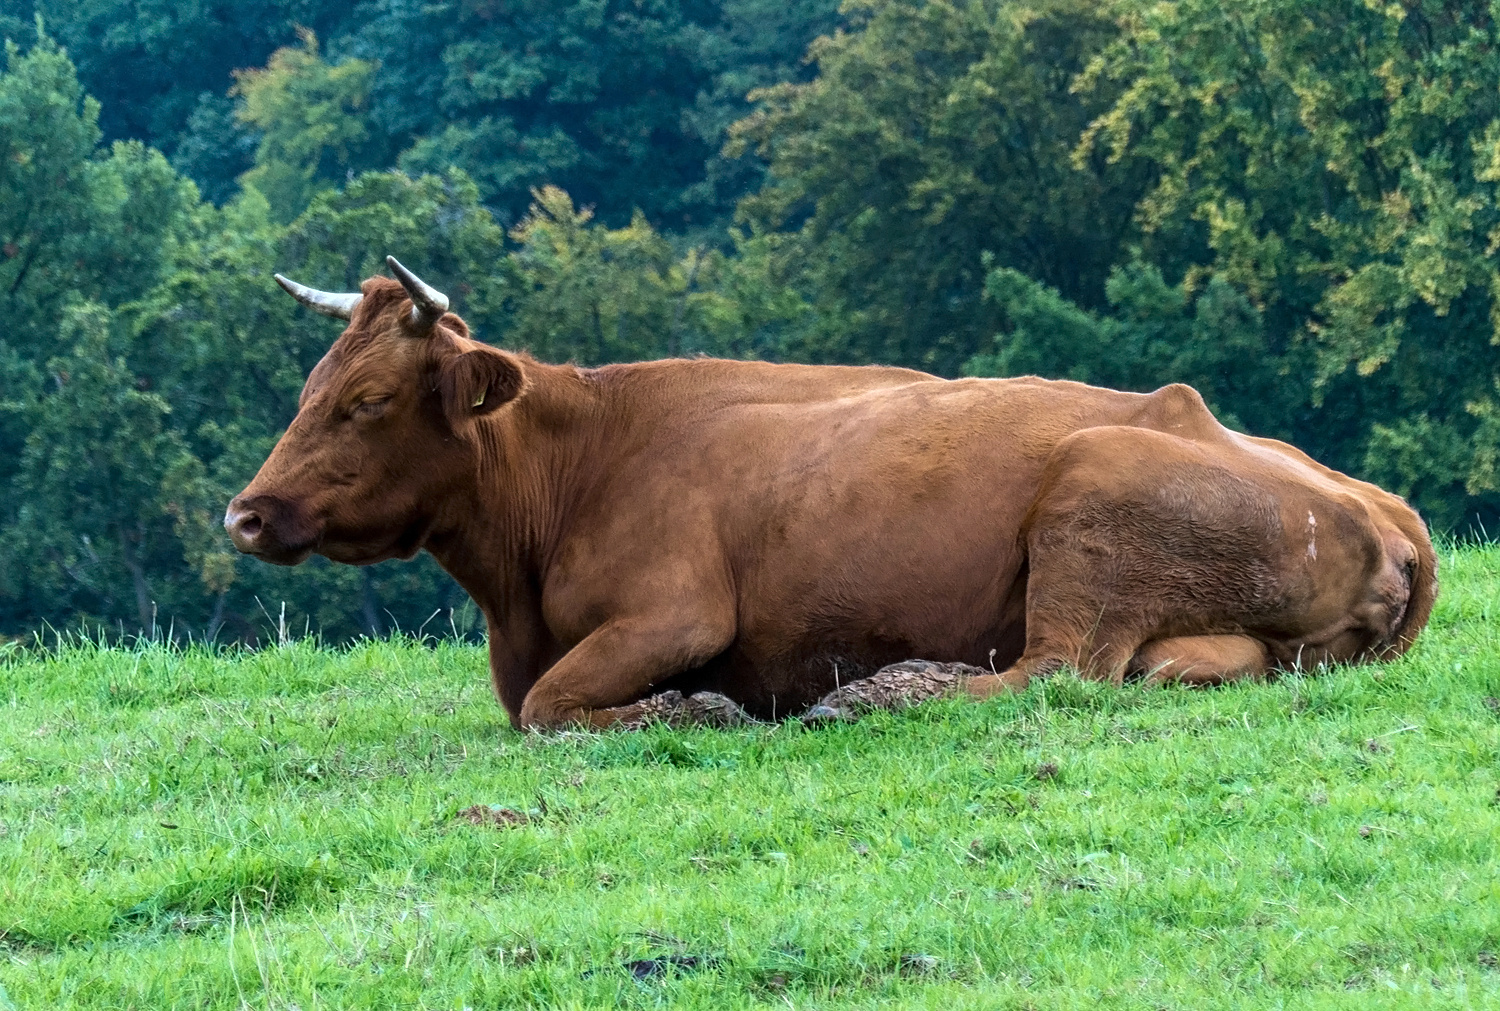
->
<box><xmin>1008</xmin><ymin>428</ymin><xmax>1281</xmax><ymax>684</ymax></box>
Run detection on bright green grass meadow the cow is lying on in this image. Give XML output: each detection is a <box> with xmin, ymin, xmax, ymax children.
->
<box><xmin>0</xmin><ymin>549</ymin><xmax>1500</xmax><ymax>1011</ymax></box>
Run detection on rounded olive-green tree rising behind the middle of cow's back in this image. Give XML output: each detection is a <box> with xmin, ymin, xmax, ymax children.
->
<box><xmin>734</xmin><ymin>0</ymin><xmax>1139</xmax><ymax>375</ymax></box>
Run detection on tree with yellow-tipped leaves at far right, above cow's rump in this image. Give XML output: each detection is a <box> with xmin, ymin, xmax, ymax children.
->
<box><xmin>1077</xmin><ymin>0</ymin><xmax>1500</xmax><ymax>524</ymax></box>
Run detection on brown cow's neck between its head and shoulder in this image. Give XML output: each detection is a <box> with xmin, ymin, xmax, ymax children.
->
<box><xmin>429</xmin><ymin>359</ymin><xmax>606</xmax><ymax>612</ymax></box>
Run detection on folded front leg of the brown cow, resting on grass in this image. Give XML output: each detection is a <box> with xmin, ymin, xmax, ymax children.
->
<box><xmin>521</xmin><ymin>617</ymin><xmax>735</xmax><ymax>729</ymax></box>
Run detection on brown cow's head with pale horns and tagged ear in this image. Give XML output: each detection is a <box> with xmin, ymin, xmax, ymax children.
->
<box><xmin>224</xmin><ymin>257</ymin><xmax>527</xmax><ymax>566</ymax></box>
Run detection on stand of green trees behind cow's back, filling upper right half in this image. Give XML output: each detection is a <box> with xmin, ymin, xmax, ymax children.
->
<box><xmin>735</xmin><ymin>0</ymin><xmax>1500</xmax><ymax>525</ymax></box>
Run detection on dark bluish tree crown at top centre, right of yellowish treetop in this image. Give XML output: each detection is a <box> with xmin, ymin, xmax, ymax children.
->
<box><xmin>375</xmin><ymin>0</ymin><xmax>836</xmax><ymax>231</ymax></box>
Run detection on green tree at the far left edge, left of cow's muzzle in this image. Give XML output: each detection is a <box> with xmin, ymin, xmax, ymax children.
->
<box><xmin>0</xmin><ymin>36</ymin><xmax>208</xmax><ymax>624</ymax></box>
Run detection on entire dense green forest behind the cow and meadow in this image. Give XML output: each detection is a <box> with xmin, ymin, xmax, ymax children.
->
<box><xmin>0</xmin><ymin>0</ymin><xmax>1500</xmax><ymax>639</ymax></box>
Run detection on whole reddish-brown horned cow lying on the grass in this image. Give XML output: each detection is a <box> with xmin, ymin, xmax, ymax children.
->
<box><xmin>225</xmin><ymin>261</ymin><xmax>1437</xmax><ymax>728</ymax></box>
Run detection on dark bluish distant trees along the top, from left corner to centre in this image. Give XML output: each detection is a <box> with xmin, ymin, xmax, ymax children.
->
<box><xmin>0</xmin><ymin>0</ymin><xmax>839</xmax><ymax>229</ymax></box>
